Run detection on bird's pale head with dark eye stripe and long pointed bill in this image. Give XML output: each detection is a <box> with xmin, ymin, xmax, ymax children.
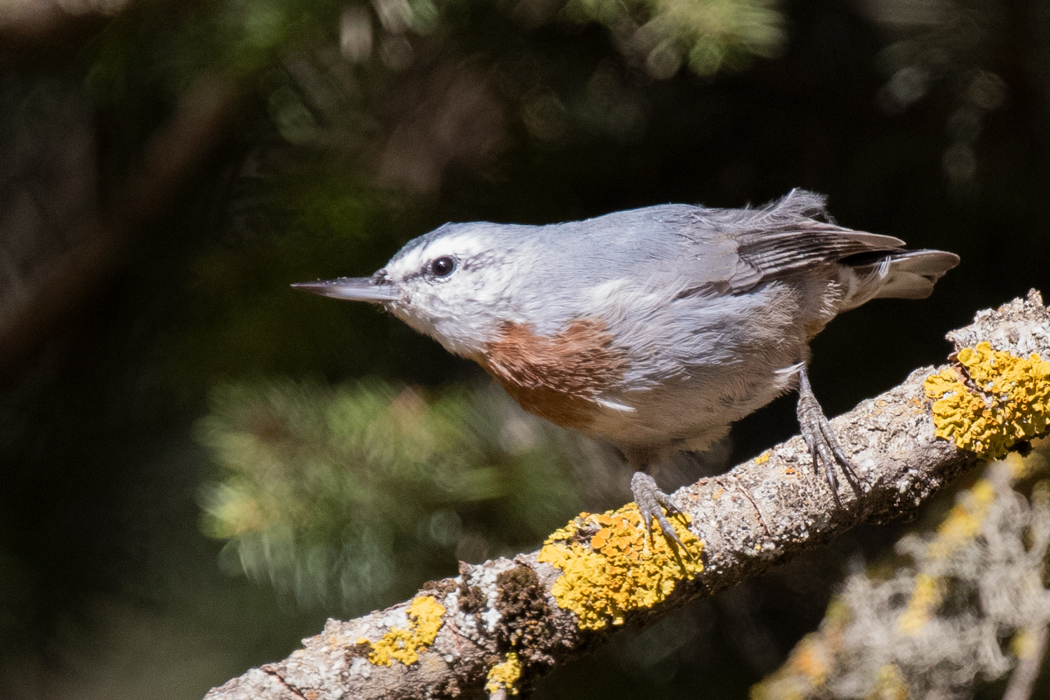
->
<box><xmin>292</xmin><ymin>222</ymin><xmax>529</xmax><ymax>358</ymax></box>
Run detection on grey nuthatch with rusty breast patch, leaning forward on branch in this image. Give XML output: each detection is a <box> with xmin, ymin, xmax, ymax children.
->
<box><xmin>293</xmin><ymin>189</ymin><xmax>960</xmax><ymax>549</ymax></box>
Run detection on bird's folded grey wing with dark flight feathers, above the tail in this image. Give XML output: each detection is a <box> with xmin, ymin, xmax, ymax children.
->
<box><xmin>679</xmin><ymin>190</ymin><xmax>904</xmax><ymax>296</ymax></box>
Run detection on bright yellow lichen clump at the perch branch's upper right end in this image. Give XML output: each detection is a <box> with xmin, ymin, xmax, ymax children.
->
<box><xmin>925</xmin><ymin>342</ymin><xmax>1050</xmax><ymax>460</ymax></box>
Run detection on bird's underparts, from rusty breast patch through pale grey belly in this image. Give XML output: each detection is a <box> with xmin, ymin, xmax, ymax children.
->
<box><xmin>476</xmin><ymin>284</ymin><xmax>806</xmax><ymax>449</ymax></box>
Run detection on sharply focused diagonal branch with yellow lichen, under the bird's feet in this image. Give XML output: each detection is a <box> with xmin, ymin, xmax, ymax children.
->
<box><xmin>202</xmin><ymin>292</ymin><xmax>1050</xmax><ymax>700</ymax></box>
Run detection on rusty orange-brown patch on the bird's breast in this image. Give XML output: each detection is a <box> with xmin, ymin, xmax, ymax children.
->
<box><xmin>477</xmin><ymin>319</ymin><xmax>628</xmax><ymax>429</ymax></box>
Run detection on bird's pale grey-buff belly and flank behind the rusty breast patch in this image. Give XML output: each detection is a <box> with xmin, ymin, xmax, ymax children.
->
<box><xmin>585</xmin><ymin>283</ymin><xmax>809</xmax><ymax>450</ymax></box>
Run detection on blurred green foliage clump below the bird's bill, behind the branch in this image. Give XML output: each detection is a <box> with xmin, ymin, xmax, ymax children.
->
<box><xmin>197</xmin><ymin>380</ymin><xmax>623</xmax><ymax>611</ymax></box>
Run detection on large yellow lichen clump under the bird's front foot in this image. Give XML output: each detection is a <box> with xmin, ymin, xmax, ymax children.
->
<box><xmin>540</xmin><ymin>503</ymin><xmax>704</xmax><ymax>630</ymax></box>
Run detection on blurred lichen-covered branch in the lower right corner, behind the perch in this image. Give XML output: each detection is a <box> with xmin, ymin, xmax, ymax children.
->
<box><xmin>750</xmin><ymin>447</ymin><xmax>1050</xmax><ymax>700</ymax></box>
